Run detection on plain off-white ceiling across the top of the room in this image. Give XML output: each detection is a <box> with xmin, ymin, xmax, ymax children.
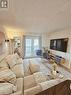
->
<box><xmin>0</xmin><ymin>0</ymin><xmax>71</xmax><ymax>33</ymax></box>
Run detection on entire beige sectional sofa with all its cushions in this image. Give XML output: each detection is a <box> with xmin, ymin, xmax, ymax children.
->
<box><xmin>0</xmin><ymin>54</ymin><xmax>67</xmax><ymax>95</ymax></box>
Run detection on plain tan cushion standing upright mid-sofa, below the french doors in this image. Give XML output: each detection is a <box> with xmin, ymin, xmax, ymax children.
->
<box><xmin>29</xmin><ymin>60</ymin><xmax>40</xmax><ymax>74</ymax></box>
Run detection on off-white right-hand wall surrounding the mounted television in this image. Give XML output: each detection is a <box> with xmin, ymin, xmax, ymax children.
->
<box><xmin>47</xmin><ymin>29</ymin><xmax>71</xmax><ymax>59</ymax></box>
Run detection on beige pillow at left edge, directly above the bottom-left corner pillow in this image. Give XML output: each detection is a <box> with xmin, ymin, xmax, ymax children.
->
<box><xmin>0</xmin><ymin>68</ymin><xmax>16</xmax><ymax>84</ymax></box>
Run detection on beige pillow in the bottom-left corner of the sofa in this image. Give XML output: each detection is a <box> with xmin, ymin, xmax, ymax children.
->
<box><xmin>0</xmin><ymin>83</ymin><xmax>17</xmax><ymax>95</ymax></box>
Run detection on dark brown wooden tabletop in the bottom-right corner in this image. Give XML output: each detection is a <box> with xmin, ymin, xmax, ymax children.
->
<box><xmin>36</xmin><ymin>80</ymin><xmax>71</xmax><ymax>95</ymax></box>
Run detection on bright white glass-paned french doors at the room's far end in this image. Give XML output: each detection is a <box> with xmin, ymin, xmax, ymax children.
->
<box><xmin>25</xmin><ymin>36</ymin><xmax>41</xmax><ymax>57</ymax></box>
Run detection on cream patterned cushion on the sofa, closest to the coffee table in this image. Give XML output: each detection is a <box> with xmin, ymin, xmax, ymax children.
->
<box><xmin>33</xmin><ymin>72</ymin><xmax>47</xmax><ymax>84</ymax></box>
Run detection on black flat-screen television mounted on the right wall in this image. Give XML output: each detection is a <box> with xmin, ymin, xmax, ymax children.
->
<box><xmin>50</xmin><ymin>38</ymin><xmax>68</xmax><ymax>52</ymax></box>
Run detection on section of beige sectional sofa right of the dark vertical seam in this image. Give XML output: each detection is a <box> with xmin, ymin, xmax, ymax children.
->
<box><xmin>24</xmin><ymin>59</ymin><xmax>63</xmax><ymax>95</ymax></box>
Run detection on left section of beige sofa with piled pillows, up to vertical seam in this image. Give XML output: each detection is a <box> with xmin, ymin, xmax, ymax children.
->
<box><xmin>0</xmin><ymin>54</ymin><xmax>24</xmax><ymax>95</ymax></box>
